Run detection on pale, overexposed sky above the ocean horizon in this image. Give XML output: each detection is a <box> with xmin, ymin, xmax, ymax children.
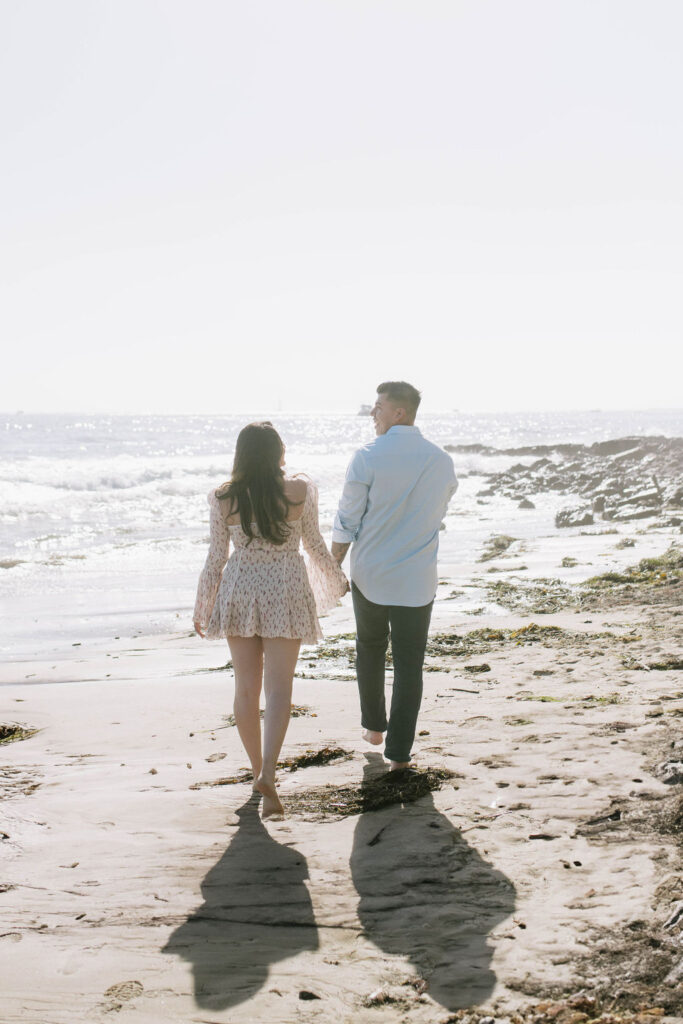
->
<box><xmin>0</xmin><ymin>0</ymin><xmax>683</xmax><ymax>413</ymax></box>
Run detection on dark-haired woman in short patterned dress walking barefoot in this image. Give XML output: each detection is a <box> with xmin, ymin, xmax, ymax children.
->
<box><xmin>195</xmin><ymin>422</ymin><xmax>348</xmax><ymax>817</ymax></box>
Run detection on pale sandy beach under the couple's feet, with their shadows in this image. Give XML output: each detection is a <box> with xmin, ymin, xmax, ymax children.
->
<box><xmin>0</xmin><ymin>535</ymin><xmax>683</xmax><ymax>1024</ymax></box>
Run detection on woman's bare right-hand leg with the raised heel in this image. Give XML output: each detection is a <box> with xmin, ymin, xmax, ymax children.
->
<box><xmin>256</xmin><ymin>637</ymin><xmax>301</xmax><ymax>818</ymax></box>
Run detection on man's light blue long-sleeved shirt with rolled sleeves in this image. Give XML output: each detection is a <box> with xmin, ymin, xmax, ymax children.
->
<box><xmin>332</xmin><ymin>426</ymin><xmax>458</xmax><ymax>607</ymax></box>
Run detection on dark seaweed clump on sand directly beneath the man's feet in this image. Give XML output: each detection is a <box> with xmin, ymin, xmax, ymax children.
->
<box><xmin>287</xmin><ymin>768</ymin><xmax>457</xmax><ymax>820</ymax></box>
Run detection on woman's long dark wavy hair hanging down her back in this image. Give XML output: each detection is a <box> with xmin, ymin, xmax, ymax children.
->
<box><xmin>216</xmin><ymin>421</ymin><xmax>295</xmax><ymax>544</ymax></box>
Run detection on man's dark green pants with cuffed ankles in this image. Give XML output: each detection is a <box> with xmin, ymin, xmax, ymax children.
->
<box><xmin>351</xmin><ymin>584</ymin><xmax>434</xmax><ymax>761</ymax></box>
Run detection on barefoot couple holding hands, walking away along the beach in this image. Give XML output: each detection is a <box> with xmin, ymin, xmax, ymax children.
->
<box><xmin>195</xmin><ymin>381</ymin><xmax>457</xmax><ymax>817</ymax></box>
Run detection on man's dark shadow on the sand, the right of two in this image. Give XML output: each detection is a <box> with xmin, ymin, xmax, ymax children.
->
<box><xmin>351</xmin><ymin>754</ymin><xmax>515</xmax><ymax>1010</ymax></box>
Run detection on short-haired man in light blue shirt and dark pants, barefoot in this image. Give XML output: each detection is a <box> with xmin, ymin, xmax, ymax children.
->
<box><xmin>332</xmin><ymin>381</ymin><xmax>458</xmax><ymax>770</ymax></box>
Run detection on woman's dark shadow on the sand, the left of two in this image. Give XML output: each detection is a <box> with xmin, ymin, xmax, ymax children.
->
<box><xmin>163</xmin><ymin>795</ymin><xmax>318</xmax><ymax>1010</ymax></box>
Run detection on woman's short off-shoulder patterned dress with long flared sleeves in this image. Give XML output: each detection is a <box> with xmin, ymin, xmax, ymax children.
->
<box><xmin>195</xmin><ymin>480</ymin><xmax>347</xmax><ymax>643</ymax></box>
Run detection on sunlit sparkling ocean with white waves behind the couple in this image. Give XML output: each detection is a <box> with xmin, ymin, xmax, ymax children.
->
<box><xmin>0</xmin><ymin>410</ymin><xmax>683</xmax><ymax>658</ymax></box>
